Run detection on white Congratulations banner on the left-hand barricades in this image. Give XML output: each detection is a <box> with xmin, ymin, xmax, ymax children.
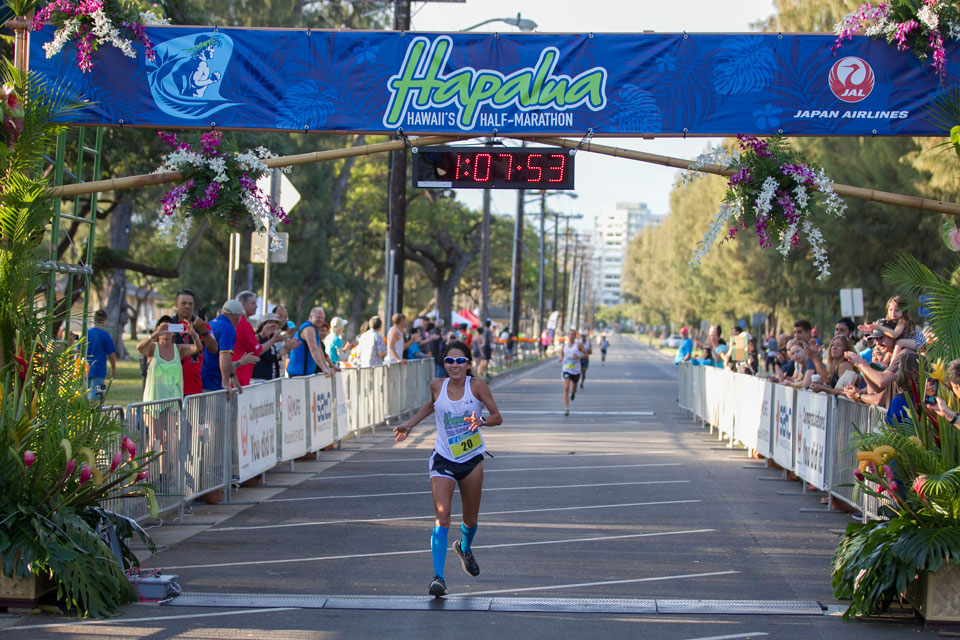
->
<box><xmin>237</xmin><ymin>383</ymin><xmax>277</xmax><ymax>482</ymax></box>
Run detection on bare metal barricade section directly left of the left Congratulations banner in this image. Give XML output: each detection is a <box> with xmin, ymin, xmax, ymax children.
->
<box><xmin>180</xmin><ymin>391</ymin><xmax>233</xmax><ymax>500</ymax></box>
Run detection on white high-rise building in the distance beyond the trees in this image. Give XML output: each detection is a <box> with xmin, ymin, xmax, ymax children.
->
<box><xmin>592</xmin><ymin>202</ymin><xmax>663</xmax><ymax>307</ymax></box>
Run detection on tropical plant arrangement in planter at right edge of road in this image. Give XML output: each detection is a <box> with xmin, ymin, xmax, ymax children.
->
<box><xmin>832</xmin><ymin>254</ymin><xmax>960</xmax><ymax>624</ymax></box>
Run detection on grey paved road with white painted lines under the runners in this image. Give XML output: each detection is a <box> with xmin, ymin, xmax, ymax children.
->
<box><xmin>0</xmin><ymin>338</ymin><xmax>928</xmax><ymax>640</ymax></box>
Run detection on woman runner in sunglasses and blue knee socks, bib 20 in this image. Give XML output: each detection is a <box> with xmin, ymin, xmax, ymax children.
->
<box><xmin>393</xmin><ymin>341</ymin><xmax>503</xmax><ymax>598</ymax></box>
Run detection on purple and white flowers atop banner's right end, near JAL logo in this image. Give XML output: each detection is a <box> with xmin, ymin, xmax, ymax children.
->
<box><xmin>831</xmin><ymin>0</ymin><xmax>960</xmax><ymax>78</ymax></box>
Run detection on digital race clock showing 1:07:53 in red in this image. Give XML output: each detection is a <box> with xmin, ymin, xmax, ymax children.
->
<box><xmin>413</xmin><ymin>146</ymin><xmax>573</xmax><ymax>190</ymax></box>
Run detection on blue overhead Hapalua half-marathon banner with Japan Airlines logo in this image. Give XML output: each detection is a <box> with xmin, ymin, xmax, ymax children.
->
<box><xmin>30</xmin><ymin>25</ymin><xmax>960</xmax><ymax>137</ymax></box>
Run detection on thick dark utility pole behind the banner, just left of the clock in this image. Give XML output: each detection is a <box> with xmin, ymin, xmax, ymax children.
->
<box><xmin>383</xmin><ymin>0</ymin><xmax>410</xmax><ymax>326</ymax></box>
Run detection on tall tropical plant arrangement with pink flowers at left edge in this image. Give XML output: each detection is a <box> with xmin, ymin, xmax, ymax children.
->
<box><xmin>0</xmin><ymin>66</ymin><xmax>157</xmax><ymax>616</ymax></box>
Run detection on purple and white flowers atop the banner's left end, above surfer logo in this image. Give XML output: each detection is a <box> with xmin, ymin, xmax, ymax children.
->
<box><xmin>33</xmin><ymin>0</ymin><xmax>165</xmax><ymax>73</ymax></box>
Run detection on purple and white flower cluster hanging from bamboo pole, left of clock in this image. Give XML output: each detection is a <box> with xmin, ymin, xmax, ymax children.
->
<box><xmin>157</xmin><ymin>131</ymin><xmax>289</xmax><ymax>246</ymax></box>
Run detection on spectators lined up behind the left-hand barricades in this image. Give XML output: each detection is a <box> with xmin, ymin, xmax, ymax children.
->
<box><xmin>87</xmin><ymin>289</ymin><xmax>540</xmax><ymax>402</ymax></box>
